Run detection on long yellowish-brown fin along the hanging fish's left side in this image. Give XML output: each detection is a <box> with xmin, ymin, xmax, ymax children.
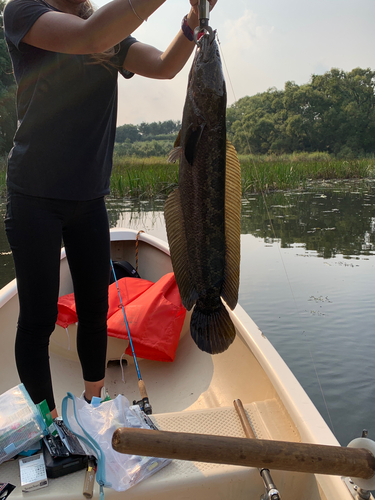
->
<box><xmin>164</xmin><ymin>188</ymin><xmax>198</xmax><ymax>311</ymax></box>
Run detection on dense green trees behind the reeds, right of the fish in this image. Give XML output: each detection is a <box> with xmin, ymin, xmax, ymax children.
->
<box><xmin>227</xmin><ymin>68</ymin><xmax>375</xmax><ymax>157</ymax></box>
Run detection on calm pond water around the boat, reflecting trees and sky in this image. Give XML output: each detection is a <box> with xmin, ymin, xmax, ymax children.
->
<box><xmin>0</xmin><ymin>182</ymin><xmax>375</xmax><ymax>446</ymax></box>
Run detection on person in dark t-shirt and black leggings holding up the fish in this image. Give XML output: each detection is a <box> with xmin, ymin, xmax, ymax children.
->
<box><xmin>4</xmin><ymin>0</ymin><xmax>217</xmax><ymax>417</ymax></box>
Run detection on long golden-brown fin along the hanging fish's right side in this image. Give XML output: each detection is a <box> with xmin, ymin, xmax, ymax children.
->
<box><xmin>221</xmin><ymin>140</ymin><xmax>241</xmax><ymax>309</ymax></box>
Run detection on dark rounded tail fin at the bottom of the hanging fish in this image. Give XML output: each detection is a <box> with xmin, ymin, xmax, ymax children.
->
<box><xmin>190</xmin><ymin>301</ymin><xmax>236</xmax><ymax>354</ymax></box>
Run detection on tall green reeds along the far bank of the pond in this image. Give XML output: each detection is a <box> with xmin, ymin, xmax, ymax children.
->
<box><xmin>0</xmin><ymin>153</ymin><xmax>375</xmax><ymax>199</ymax></box>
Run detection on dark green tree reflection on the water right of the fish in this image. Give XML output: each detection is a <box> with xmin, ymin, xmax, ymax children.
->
<box><xmin>241</xmin><ymin>183</ymin><xmax>375</xmax><ymax>259</ymax></box>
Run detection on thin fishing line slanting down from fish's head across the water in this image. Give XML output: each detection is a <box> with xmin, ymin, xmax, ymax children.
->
<box><xmin>216</xmin><ymin>31</ymin><xmax>336</xmax><ymax>435</ymax></box>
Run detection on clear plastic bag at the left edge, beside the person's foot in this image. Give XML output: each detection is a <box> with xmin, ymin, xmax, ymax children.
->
<box><xmin>0</xmin><ymin>384</ymin><xmax>47</xmax><ymax>464</ymax></box>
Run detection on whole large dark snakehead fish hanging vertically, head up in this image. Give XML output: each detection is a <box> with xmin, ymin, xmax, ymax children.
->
<box><xmin>164</xmin><ymin>34</ymin><xmax>241</xmax><ymax>354</ymax></box>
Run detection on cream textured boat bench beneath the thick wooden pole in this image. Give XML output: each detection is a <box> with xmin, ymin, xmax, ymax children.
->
<box><xmin>1</xmin><ymin>399</ymin><xmax>321</xmax><ymax>500</ymax></box>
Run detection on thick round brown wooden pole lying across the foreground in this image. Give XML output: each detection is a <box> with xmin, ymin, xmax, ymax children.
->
<box><xmin>112</xmin><ymin>428</ymin><xmax>375</xmax><ymax>479</ymax></box>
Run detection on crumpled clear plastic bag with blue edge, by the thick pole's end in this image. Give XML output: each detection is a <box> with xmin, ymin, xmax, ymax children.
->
<box><xmin>62</xmin><ymin>392</ymin><xmax>171</xmax><ymax>498</ymax></box>
